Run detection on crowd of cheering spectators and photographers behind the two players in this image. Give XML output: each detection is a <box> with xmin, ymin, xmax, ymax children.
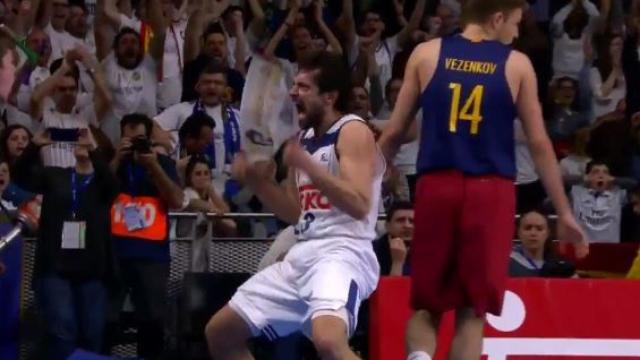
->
<box><xmin>0</xmin><ymin>0</ymin><xmax>640</xmax><ymax>359</ymax></box>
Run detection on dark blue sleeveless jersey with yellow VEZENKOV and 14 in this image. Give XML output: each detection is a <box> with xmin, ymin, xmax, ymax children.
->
<box><xmin>417</xmin><ymin>35</ymin><xmax>517</xmax><ymax>178</ymax></box>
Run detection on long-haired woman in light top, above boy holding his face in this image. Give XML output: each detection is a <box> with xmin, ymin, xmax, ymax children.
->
<box><xmin>590</xmin><ymin>35</ymin><xmax>627</xmax><ymax>120</ymax></box>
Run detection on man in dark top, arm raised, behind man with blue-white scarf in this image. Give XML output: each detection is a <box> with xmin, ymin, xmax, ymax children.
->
<box><xmin>182</xmin><ymin>2</ymin><xmax>244</xmax><ymax>102</ymax></box>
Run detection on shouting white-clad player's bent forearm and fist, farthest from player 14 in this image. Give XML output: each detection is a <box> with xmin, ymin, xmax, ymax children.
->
<box><xmin>232</xmin><ymin>153</ymin><xmax>301</xmax><ymax>225</ymax></box>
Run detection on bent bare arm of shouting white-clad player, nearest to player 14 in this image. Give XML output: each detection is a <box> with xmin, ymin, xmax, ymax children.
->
<box><xmin>284</xmin><ymin>121</ymin><xmax>379</xmax><ymax>220</ymax></box>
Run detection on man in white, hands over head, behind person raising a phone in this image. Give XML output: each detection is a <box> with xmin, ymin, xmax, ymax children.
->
<box><xmin>30</xmin><ymin>47</ymin><xmax>111</xmax><ymax>167</ymax></box>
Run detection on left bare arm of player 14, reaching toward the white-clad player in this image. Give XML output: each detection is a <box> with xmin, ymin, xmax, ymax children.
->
<box><xmin>379</xmin><ymin>39</ymin><xmax>440</xmax><ymax>160</ymax></box>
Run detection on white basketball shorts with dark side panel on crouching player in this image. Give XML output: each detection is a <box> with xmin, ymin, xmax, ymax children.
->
<box><xmin>229</xmin><ymin>239</ymin><xmax>380</xmax><ymax>340</ymax></box>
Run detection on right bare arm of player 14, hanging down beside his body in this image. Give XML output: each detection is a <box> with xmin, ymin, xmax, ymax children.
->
<box><xmin>507</xmin><ymin>51</ymin><xmax>588</xmax><ymax>256</ymax></box>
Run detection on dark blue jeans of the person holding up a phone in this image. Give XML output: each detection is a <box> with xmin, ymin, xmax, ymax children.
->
<box><xmin>35</xmin><ymin>274</ymin><xmax>107</xmax><ymax>360</ymax></box>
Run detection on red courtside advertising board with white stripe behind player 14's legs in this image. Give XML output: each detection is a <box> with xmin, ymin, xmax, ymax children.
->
<box><xmin>370</xmin><ymin>277</ymin><xmax>640</xmax><ymax>360</ymax></box>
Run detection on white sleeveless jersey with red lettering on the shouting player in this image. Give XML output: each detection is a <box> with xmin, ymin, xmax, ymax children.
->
<box><xmin>296</xmin><ymin>114</ymin><xmax>385</xmax><ymax>241</ymax></box>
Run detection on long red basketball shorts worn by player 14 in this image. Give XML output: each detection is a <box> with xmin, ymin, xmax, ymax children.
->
<box><xmin>410</xmin><ymin>171</ymin><xmax>515</xmax><ymax>316</ymax></box>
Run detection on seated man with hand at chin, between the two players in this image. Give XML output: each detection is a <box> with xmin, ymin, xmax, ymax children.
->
<box><xmin>373</xmin><ymin>201</ymin><xmax>413</xmax><ymax>276</ymax></box>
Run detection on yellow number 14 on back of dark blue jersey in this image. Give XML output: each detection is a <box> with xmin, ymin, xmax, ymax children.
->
<box><xmin>449</xmin><ymin>83</ymin><xmax>484</xmax><ymax>135</ymax></box>
